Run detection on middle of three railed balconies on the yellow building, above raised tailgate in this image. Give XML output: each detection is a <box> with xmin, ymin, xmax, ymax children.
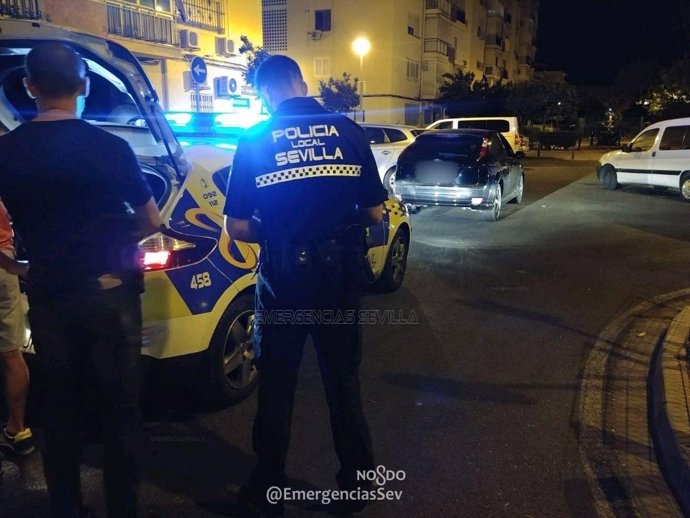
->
<box><xmin>106</xmin><ymin>3</ymin><xmax>177</xmax><ymax>45</ymax></box>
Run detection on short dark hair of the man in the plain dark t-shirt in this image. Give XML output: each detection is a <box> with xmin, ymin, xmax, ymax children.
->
<box><xmin>25</xmin><ymin>41</ymin><xmax>86</xmax><ymax>98</ymax></box>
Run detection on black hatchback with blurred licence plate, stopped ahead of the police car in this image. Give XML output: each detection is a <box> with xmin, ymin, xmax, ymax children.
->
<box><xmin>395</xmin><ymin>130</ymin><xmax>525</xmax><ymax>221</ymax></box>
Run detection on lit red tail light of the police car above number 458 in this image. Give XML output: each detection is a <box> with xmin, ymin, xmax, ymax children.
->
<box><xmin>139</xmin><ymin>229</ymin><xmax>216</xmax><ymax>271</ymax></box>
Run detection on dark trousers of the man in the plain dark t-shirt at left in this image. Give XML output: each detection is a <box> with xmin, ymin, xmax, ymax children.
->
<box><xmin>29</xmin><ymin>285</ymin><xmax>143</xmax><ymax>518</ymax></box>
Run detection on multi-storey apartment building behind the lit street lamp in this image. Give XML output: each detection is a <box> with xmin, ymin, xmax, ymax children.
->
<box><xmin>261</xmin><ymin>0</ymin><xmax>539</xmax><ymax>125</ymax></box>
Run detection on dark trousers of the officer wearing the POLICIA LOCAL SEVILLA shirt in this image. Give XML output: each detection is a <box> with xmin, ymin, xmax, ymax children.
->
<box><xmin>250</xmin><ymin>274</ymin><xmax>374</xmax><ymax>494</ymax></box>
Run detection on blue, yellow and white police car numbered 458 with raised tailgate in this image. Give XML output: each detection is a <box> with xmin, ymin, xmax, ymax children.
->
<box><xmin>0</xmin><ymin>20</ymin><xmax>410</xmax><ymax>403</ymax></box>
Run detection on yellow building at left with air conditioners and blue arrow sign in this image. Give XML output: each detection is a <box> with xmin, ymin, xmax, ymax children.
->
<box><xmin>0</xmin><ymin>0</ymin><xmax>261</xmax><ymax>115</ymax></box>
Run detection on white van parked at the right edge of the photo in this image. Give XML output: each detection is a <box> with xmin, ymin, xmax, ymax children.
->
<box><xmin>597</xmin><ymin>117</ymin><xmax>690</xmax><ymax>201</ymax></box>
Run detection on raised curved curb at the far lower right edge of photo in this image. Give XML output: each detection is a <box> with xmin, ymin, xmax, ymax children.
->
<box><xmin>647</xmin><ymin>306</ymin><xmax>690</xmax><ymax>516</ymax></box>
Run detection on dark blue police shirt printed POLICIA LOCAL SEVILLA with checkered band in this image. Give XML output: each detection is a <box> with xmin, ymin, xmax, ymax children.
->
<box><xmin>224</xmin><ymin>97</ymin><xmax>387</xmax><ymax>248</ymax></box>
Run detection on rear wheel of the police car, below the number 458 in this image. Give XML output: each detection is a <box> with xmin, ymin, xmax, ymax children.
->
<box><xmin>202</xmin><ymin>294</ymin><xmax>258</xmax><ymax>404</ymax></box>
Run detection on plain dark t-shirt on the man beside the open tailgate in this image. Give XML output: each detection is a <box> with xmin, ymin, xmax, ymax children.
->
<box><xmin>0</xmin><ymin>119</ymin><xmax>151</xmax><ymax>292</ymax></box>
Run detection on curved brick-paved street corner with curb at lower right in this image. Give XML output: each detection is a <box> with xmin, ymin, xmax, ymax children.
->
<box><xmin>577</xmin><ymin>289</ymin><xmax>690</xmax><ymax>518</ymax></box>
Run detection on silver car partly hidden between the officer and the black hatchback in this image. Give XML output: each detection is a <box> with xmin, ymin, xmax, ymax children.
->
<box><xmin>360</xmin><ymin>123</ymin><xmax>424</xmax><ymax>192</ymax></box>
